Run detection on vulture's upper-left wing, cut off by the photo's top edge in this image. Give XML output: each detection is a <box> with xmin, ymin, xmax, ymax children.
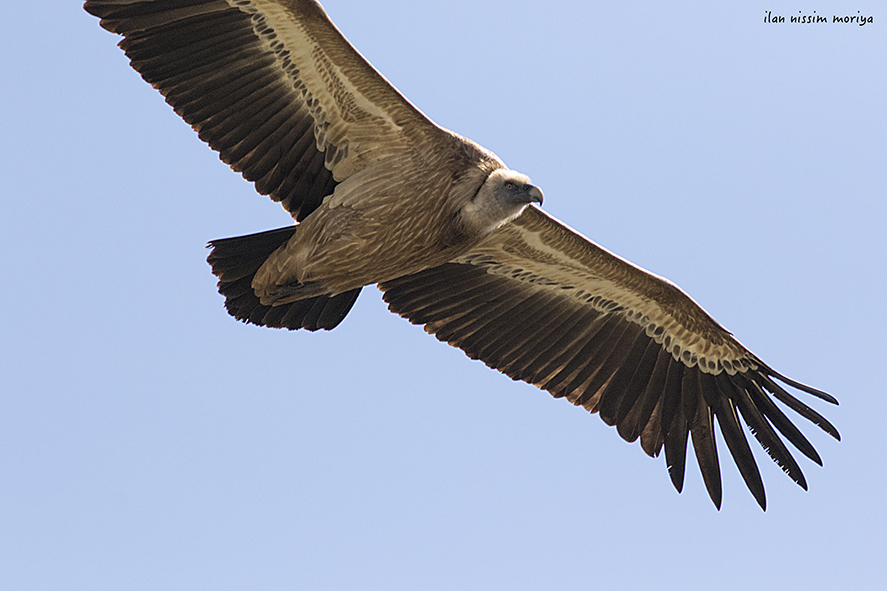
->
<box><xmin>85</xmin><ymin>0</ymin><xmax>476</xmax><ymax>220</ymax></box>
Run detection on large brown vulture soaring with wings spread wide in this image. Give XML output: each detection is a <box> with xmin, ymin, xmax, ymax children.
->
<box><xmin>85</xmin><ymin>0</ymin><xmax>840</xmax><ymax>509</ymax></box>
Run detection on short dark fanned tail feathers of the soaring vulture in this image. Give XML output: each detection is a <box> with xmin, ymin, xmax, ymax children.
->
<box><xmin>206</xmin><ymin>226</ymin><xmax>361</xmax><ymax>330</ymax></box>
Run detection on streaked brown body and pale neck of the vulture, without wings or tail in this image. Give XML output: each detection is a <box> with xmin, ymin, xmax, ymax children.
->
<box><xmin>252</xmin><ymin>148</ymin><xmax>527</xmax><ymax>304</ymax></box>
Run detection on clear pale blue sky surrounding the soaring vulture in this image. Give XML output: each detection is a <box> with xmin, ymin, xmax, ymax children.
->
<box><xmin>0</xmin><ymin>0</ymin><xmax>887</xmax><ymax>590</ymax></box>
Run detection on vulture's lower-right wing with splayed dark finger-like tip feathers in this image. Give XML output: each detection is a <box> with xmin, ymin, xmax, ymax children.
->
<box><xmin>379</xmin><ymin>207</ymin><xmax>839</xmax><ymax>508</ymax></box>
